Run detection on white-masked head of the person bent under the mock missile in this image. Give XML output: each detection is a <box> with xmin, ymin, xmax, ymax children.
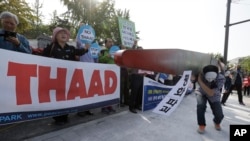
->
<box><xmin>203</xmin><ymin>65</ymin><xmax>219</xmax><ymax>82</ymax></box>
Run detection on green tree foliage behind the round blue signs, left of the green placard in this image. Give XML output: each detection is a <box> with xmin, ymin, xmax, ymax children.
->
<box><xmin>61</xmin><ymin>0</ymin><xmax>133</xmax><ymax>44</ymax></box>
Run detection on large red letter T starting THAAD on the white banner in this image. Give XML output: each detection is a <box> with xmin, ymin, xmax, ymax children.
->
<box><xmin>7</xmin><ymin>62</ymin><xmax>37</xmax><ymax>105</ymax></box>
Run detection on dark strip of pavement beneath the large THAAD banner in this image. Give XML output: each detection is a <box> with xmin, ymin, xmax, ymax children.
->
<box><xmin>0</xmin><ymin>106</ymin><xmax>128</xmax><ymax>141</ymax></box>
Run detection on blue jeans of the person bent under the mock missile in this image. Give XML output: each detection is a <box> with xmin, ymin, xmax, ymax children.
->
<box><xmin>196</xmin><ymin>93</ymin><xmax>224</xmax><ymax>126</ymax></box>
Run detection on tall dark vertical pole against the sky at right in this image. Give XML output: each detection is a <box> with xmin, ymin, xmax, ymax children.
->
<box><xmin>224</xmin><ymin>0</ymin><xmax>231</xmax><ymax>64</ymax></box>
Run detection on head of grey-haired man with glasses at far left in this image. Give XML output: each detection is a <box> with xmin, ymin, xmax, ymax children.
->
<box><xmin>0</xmin><ymin>11</ymin><xmax>19</xmax><ymax>32</ymax></box>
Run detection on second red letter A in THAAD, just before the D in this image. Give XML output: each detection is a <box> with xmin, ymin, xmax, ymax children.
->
<box><xmin>88</xmin><ymin>70</ymin><xmax>104</xmax><ymax>97</ymax></box>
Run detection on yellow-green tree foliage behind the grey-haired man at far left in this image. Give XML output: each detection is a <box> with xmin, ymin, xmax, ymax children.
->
<box><xmin>0</xmin><ymin>0</ymin><xmax>36</xmax><ymax>34</ymax></box>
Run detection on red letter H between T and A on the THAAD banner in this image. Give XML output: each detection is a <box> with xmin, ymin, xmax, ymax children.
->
<box><xmin>38</xmin><ymin>66</ymin><xmax>67</xmax><ymax>103</ymax></box>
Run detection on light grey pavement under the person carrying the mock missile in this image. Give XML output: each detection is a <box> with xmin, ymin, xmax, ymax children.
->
<box><xmin>24</xmin><ymin>94</ymin><xmax>250</xmax><ymax>141</ymax></box>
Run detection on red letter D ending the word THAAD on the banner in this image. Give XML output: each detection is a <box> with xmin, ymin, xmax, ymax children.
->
<box><xmin>104</xmin><ymin>70</ymin><xmax>117</xmax><ymax>94</ymax></box>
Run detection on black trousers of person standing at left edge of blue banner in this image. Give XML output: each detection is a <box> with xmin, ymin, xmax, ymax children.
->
<box><xmin>129</xmin><ymin>74</ymin><xmax>143</xmax><ymax>108</ymax></box>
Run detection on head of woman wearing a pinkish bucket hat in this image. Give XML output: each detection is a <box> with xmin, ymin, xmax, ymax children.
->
<box><xmin>52</xmin><ymin>27</ymin><xmax>70</xmax><ymax>43</ymax></box>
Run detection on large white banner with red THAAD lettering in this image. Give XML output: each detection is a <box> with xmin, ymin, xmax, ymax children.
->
<box><xmin>0</xmin><ymin>49</ymin><xmax>120</xmax><ymax>124</ymax></box>
